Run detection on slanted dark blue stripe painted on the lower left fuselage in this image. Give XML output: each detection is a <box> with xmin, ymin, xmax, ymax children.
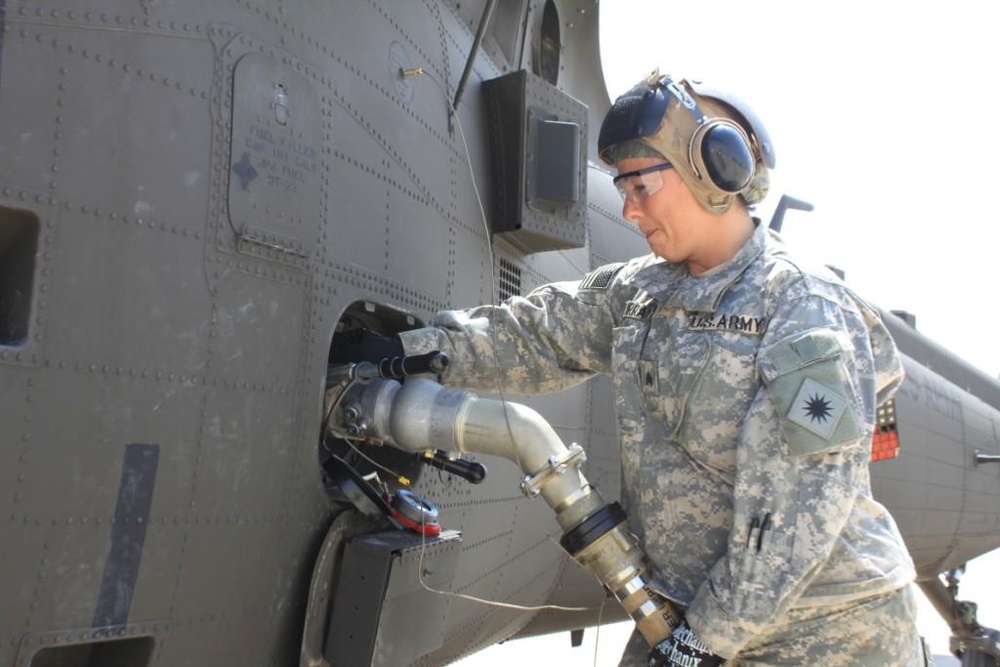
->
<box><xmin>93</xmin><ymin>444</ymin><xmax>160</xmax><ymax>628</ymax></box>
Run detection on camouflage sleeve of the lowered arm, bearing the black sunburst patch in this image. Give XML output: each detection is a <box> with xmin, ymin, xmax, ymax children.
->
<box><xmin>687</xmin><ymin>296</ymin><xmax>898</xmax><ymax>657</ymax></box>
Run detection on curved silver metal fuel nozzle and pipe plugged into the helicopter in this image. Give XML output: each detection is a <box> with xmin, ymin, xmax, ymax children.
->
<box><xmin>330</xmin><ymin>374</ymin><xmax>680</xmax><ymax>646</ymax></box>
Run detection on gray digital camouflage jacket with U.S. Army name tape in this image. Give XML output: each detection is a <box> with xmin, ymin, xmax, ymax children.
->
<box><xmin>401</xmin><ymin>226</ymin><xmax>914</xmax><ymax>657</ymax></box>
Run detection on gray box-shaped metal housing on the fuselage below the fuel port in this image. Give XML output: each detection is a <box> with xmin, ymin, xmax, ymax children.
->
<box><xmin>324</xmin><ymin>530</ymin><xmax>461</xmax><ymax>667</ymax></box>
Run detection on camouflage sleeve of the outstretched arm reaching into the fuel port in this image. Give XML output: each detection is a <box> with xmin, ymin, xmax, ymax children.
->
<box><xmin>400</xmin><ymin>265</ymin><xmax>620</xmax><ymax>393</ymax></box>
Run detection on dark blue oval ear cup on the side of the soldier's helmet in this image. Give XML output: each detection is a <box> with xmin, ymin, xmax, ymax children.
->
<box><xmin>688</xmin><ymin>118</ymin><xmax>756</xmax><ymax>194</ymax></box>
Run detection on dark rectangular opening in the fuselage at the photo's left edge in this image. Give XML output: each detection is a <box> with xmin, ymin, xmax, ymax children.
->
<box><xmin>0</xmin><ymin>206</ymin><xmax>39</xmax><ymax>346</ymax></box>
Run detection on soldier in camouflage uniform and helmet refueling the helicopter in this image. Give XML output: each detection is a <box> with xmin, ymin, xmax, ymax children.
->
<box><xmin>401</xmin><ymin>73</ymin><xmax>923</xmax><ymax>667</ymax></box>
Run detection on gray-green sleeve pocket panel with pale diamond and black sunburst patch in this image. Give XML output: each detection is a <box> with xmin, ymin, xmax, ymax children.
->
<box><xmin>758</xmin><ymin>330</ymin><xmax>865</xmax><ymax>456</ymax></box>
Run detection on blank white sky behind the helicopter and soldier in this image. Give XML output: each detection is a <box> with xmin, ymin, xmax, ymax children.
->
<box><xmin>457</xmin><ymin>0</ymin><xmax>1000</xmax><ymax>667</ymax></box>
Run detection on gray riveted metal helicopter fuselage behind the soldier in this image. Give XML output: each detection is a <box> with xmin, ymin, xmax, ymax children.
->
<box><xmin>0</xmin><ymin>0</ymin><xmax>1000</xmax><ymax>667</ymax></box>
